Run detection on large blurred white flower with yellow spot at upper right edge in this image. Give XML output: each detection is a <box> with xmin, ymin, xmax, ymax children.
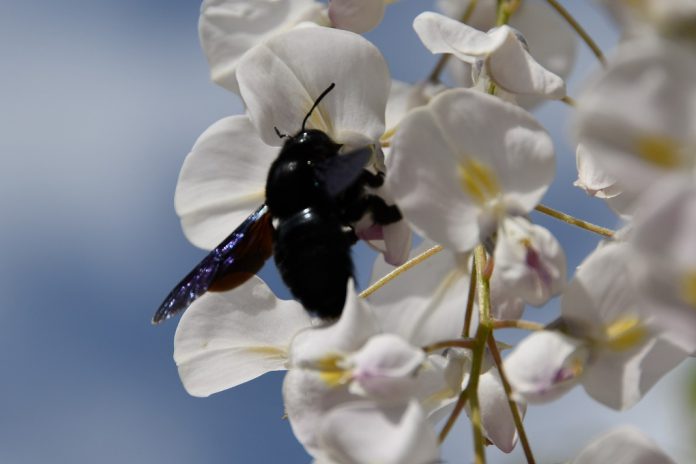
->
<box><xmin>576</xmin><ymin>36</ymin><xmax>696</xmax><ymax>205</ymax></box>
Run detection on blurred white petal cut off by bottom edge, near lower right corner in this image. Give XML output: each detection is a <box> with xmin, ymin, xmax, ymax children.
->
<box><xmin>571</xmin><ymin>426</ymin><xmax>674</xmax><ymax>464</ymax></box>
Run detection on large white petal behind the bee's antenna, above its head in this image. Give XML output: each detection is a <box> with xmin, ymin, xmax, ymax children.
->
<box><xmin>237</xmin><ymin>27</ymin><xmax>391</xmax><ymax>147</ymax></box>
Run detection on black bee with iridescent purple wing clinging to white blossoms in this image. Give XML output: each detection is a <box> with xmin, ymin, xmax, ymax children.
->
<box><xmin>152</xmin><ymin>83</ymin><xmax>401</xmax><ymax>324</ymax></box>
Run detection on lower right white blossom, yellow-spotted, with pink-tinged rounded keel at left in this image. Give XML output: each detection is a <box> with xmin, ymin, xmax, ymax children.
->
<box><xmin>505</xmin><ymin>243</ymin><xmax>696</xmax><ymax>410</ymax></box>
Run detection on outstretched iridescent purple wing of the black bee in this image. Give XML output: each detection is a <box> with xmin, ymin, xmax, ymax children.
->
<box><xmin>152</xmin><ymin>205</ymin><xmax>273</xmax><ymax>324</ymax></box>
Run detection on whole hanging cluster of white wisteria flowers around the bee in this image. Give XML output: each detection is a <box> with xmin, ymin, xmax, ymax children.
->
<box><xmin>164</xmin><ymin>0</ymin><xmax>696</xmax><ymax>464</ymax></box>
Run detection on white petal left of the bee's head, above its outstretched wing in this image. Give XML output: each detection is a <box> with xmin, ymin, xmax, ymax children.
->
<box><xmin>174</xmin><ymin>116</ymin><xmax>278</xmax><ymax>250</ymax></box>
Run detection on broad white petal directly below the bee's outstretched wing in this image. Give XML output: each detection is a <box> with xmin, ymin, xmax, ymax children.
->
<box><xmin>174</xmin><ymin>277</ymin><xmax>310</xmax><ymax>396</ymax></box>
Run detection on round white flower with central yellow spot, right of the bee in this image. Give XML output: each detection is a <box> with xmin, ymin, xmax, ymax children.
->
<box><xmin>386</xmin><ymin>89</ymin><xmax>554</xmax><ymax>252</ymax></box>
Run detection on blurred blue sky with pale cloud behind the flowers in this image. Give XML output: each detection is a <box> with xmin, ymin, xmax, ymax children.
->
<box><xmin>0</xmin><ymin>0</ymin><xmax>691</xmax><ymax>464</ymax></box>
